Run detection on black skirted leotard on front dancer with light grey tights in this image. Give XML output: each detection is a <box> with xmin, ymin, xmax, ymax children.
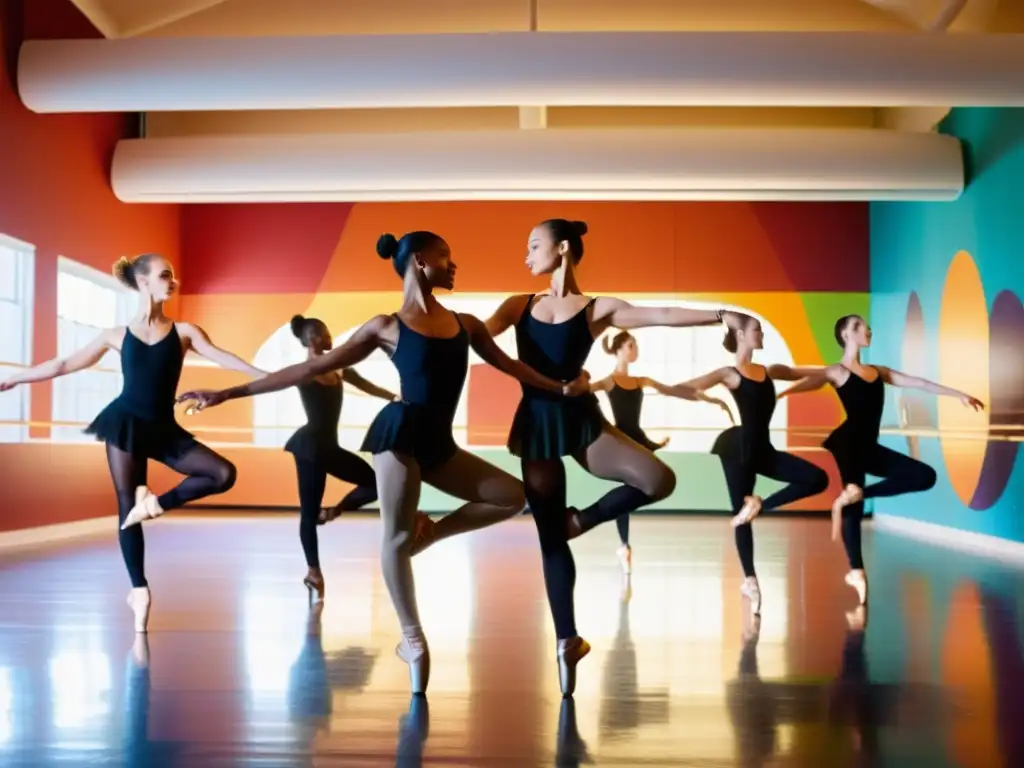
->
<box><xmin>362</xmin><ymin>312</ymin><xmax>469</xmax><ymax>470</ymax></box>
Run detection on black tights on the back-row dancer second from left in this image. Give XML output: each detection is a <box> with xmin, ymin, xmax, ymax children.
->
<box><xmin>295</xmin><ymin>445</ymin><xmax>377</xmax><ymax>568</ymax></box>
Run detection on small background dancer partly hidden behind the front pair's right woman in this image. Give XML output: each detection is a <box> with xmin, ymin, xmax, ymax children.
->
<box><xmin>590</xmin><ymin>331</ymin><xmax>732</xmax><ymax>574</ymax></box>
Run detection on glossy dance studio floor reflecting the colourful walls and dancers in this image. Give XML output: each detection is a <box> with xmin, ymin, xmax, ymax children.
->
<box><xmin>0</xmin><ymin>514</ymin><xmax>1024</xmax><ymax>768</ymax></box>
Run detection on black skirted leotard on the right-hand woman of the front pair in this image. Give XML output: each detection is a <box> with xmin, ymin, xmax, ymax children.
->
<box><xmin>508</xmin><ymin>296</ymin><xmax>605</xmax><ymax>460</ymax></box>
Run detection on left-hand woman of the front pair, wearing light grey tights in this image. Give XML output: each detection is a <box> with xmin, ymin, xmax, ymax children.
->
<box><xmin>179</xmin><ymin>231</ymin><xmax>588</xmax><ymax>693</ymax></box>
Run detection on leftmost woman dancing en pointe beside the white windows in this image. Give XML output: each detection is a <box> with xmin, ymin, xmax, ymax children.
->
<box><xmin>0</xmin><ymin>253</ymin><xmax>263</xmax><ymax>632</ymax></box>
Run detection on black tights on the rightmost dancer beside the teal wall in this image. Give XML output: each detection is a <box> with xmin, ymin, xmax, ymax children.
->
<box><xmin>829</xmin><ymin>442</ymin><xmax>936</xmax><ymax>570</ymax></box>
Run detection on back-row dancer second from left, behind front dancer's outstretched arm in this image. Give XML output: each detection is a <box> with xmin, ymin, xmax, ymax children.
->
<box><xmin>285</xmin><ymin>314</ymin><xmax>395</xmax><ymax>600</ymax></box>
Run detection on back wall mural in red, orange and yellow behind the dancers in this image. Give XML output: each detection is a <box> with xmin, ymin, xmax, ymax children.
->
<box><xmin>182</xmin><ymin>203</ymin><xmax>868</xmax><ymax>510</ymax></box>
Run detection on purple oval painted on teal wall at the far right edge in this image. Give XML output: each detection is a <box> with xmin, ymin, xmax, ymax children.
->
<box><xmin>971</xmin><ymin>291</ymin><xmax>1024</xmax><ymax>510</ymax></box>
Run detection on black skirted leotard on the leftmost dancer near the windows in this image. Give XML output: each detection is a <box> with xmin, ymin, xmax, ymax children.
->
<box><xmin>85</xmin><ymin>325</ymin><xmax>196</xmax><ymax>461</ymax></box>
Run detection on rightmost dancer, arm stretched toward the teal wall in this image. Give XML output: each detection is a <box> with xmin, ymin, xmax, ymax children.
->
<box><xmin>772</xmin><ymin>314</ymin><xmax>985</xmax><ymax>604</ymax></box>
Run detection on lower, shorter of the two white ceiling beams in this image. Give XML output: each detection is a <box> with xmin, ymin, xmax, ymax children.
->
<box><xmin>111</xmin><ymin>128</ymin><xmax>964</xmax><ymax>203</ymax></box>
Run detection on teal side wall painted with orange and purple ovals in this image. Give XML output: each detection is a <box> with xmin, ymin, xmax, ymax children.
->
<box><xmin>870</xmin><ymin>109</ymin><xmax>1024</xmax><ymax>542</ymax></box>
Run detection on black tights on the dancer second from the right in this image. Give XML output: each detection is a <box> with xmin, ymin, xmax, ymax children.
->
<box><xmin>719</xmin><ymin>449</ymin><xmax>828</xmax><ymax>578</ymax></box>
